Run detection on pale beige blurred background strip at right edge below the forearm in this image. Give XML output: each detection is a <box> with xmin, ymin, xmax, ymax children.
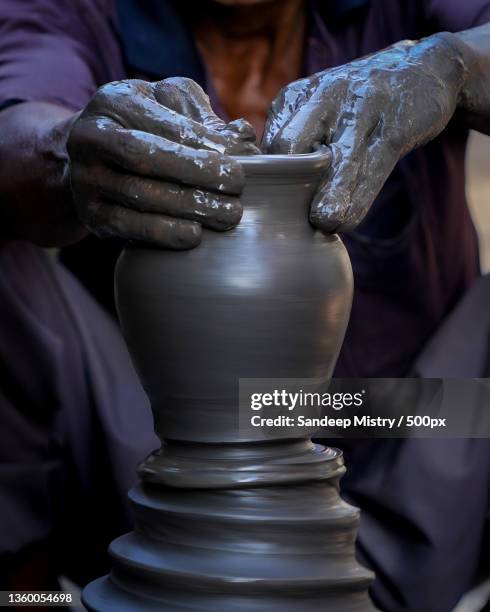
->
<box><xmin>466</xmin><ymin>133</ymin><xmax>490</xmax><ymax>272</ymax></box>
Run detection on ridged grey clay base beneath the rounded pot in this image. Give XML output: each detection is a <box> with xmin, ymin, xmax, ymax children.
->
<box><xmin>83</xmin><ymin>441</ymin><xmax>374</xmax><ymax>612</ymax></box>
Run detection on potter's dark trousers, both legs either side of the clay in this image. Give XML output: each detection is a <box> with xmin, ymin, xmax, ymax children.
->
<box><xmin>0</xmin><ymin>243</ymin><xmax>490</xmax><ymax>612</ymax></box>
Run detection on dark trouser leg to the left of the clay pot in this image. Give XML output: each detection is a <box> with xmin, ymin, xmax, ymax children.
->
<box><xmin>0</xmin><ymin>243</ymin><xmax>158</xmax><ymax>588</ymax></box>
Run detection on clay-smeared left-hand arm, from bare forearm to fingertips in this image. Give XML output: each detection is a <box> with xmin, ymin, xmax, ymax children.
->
<box><xmin>0</xmin><ymin>78</ymin><xmax>257</xmax><ymax>249</ymax></box>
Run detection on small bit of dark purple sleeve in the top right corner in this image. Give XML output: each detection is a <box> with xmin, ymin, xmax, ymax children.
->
<box><xmin>426</xmin><ymin>0</ymin><xmax>490</xmax><ymax>32</ymax></box>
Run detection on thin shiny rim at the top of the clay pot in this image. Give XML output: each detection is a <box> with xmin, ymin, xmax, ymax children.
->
<box><xmin>232</xmin><ymin>147</ymin><xmax>332</xmax><ymax>175</ymax></box>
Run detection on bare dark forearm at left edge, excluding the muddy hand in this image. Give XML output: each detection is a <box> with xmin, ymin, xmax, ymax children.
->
<box><xmin>0</xmin><ymin>102</ymin><xmax>86</xmax><ymax>246</ymax></box>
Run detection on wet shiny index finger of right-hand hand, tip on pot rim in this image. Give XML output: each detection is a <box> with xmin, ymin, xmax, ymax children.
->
<box><xmin>260</xmin><ymin>77</ymin><xmax>324</xmax><ymax>153</ymax></box>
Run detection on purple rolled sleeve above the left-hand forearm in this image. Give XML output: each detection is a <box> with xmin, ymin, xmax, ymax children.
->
<box><xmin>0</xmin><ymin>0</ymin><xmax>119</xmax><ymax>110</ymax></box>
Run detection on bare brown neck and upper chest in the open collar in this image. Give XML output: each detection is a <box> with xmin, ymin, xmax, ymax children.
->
<box><xmin>192</xmin><ymin>0</ymin><xmax>306</xmax><ymax>137</ymax></box>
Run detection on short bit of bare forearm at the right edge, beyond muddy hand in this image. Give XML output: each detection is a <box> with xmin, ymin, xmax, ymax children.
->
<box><xmin>454</xmin><ymin>23</ymin><xmax>490</xmax><ymax>135</ymax></box>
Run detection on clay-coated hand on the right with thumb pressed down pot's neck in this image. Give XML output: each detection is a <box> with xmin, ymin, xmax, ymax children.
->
<box><xmin>262</xmin><ymin>33</ymin><xmax>466</xmax><ymax>231</ymax></box>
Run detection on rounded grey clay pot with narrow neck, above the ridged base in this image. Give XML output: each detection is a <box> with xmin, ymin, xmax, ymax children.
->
<box><xmin>116</xmin><ymin>153</ymin><xmax>352</xmax><ymax>443</ymax></box>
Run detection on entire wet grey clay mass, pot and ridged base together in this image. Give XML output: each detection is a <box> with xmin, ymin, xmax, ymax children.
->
<box><xmin>83</xmin><ymin>153</ymin><xmax>374</xmax><ymax>612</ymax></box>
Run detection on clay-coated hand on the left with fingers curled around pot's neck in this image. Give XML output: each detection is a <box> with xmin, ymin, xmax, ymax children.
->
<box><xmin>67</xmin><ymin>78</ymin><xmax>258</xmax><ymax>249</ymax></box>
